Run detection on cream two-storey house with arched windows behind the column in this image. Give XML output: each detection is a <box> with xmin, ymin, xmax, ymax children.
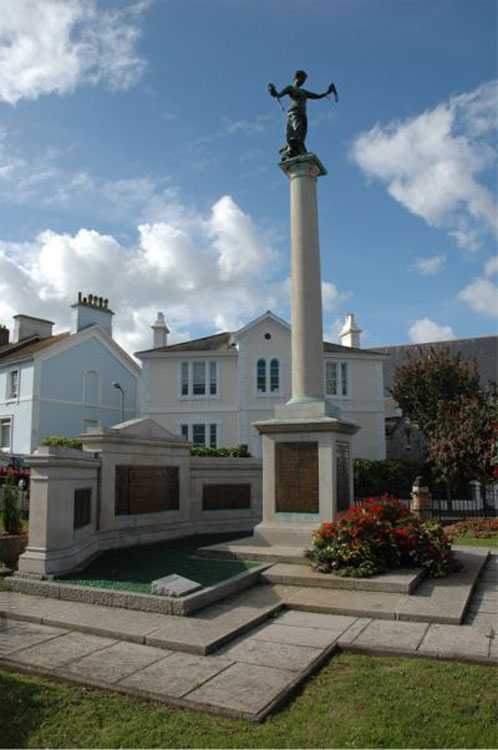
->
<box><xmin>136</xmin><ymin>312</ymin><xmax>385</xmax><ymax>459</ymax></box>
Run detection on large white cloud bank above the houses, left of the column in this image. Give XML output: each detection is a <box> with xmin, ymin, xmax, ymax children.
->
<box><xmin>0</xmin><ymin>196</ymin><xmax>296</xmax><ymax>351</ymax></box>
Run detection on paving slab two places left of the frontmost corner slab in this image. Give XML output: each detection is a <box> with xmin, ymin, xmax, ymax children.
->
<box><xmin>61</xmin><ymin>641</ymin><xmax>173</xmax><ymax>684</ymax></box>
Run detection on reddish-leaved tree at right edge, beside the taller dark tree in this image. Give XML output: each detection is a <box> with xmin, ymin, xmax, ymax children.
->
<box><xmin>428</xmin><ymin>384</ymin><xmax>498</xmax><ymax>494</ymax></box>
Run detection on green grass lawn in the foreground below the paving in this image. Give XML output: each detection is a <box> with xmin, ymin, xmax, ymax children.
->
<box><xmin>0</xmin><ymin>654</ymin><xmax>498</xmax><ymax>748</ymax></box>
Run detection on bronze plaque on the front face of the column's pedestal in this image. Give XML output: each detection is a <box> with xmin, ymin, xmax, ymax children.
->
<box><xmin>275</xmin><ymin>443</ymin><xmax>319</xmax><ymax>513</ymax></box>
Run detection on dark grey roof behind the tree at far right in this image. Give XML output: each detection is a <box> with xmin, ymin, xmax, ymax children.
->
<box><xmin>372</xmin><ymin>336</ymin><xmax>498</xmax><ymax>395</ymax></box>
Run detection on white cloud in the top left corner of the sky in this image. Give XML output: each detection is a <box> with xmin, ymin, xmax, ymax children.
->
<box><xmin>0</xmin><ymin>0</ymin><xmax>148</xmax><ymax>104</ymax></box>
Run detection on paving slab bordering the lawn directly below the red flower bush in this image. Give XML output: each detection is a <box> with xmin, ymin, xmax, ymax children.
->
<box><xmin>349</xmin><ymin>620</ymin><xmax>429</xmax><ymax>653</ymax></box>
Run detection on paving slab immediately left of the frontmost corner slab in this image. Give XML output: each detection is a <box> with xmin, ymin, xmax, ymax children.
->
<box><xmin>116</xmin><ymin>652</ymin><xmax>232</xmax><ymax>698</ymax></box>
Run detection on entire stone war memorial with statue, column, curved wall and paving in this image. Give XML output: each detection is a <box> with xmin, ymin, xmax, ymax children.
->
<box><xmin>0</xmin><ymin>75</ymin><xmax>498</xmax><ymax>721</ymax></box>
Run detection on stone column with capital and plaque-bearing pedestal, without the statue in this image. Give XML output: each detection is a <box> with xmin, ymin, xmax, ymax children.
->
<box><xmin>254</xmin><ymin>154</ymin><xmax>358</xmax><ymax>547</ymax></box>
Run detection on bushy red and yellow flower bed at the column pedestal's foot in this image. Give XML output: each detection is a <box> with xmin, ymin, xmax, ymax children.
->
<box><xmin>306</xmin><ymin>495</ymin><xmax>459</xmax><ymax>578</ymax></box>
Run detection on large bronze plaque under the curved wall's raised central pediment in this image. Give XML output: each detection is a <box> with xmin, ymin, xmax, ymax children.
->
<box><xmin>115</xmin><ymin>465</ymin><xmax>180</xmax><ymax>515</ymax></box>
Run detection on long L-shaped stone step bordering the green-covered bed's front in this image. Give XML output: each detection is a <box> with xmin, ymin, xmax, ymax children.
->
<box><xmin>0</xmin><ymin>586</ymin><xmax>282</xmax><ymax>654</ymax></box>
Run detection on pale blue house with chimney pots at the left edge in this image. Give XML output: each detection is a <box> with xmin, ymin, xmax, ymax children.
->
<box><xmin>0</xmin><ymin>293</ymin><xmax>140</xmax><ymax>455</ymax></box>
